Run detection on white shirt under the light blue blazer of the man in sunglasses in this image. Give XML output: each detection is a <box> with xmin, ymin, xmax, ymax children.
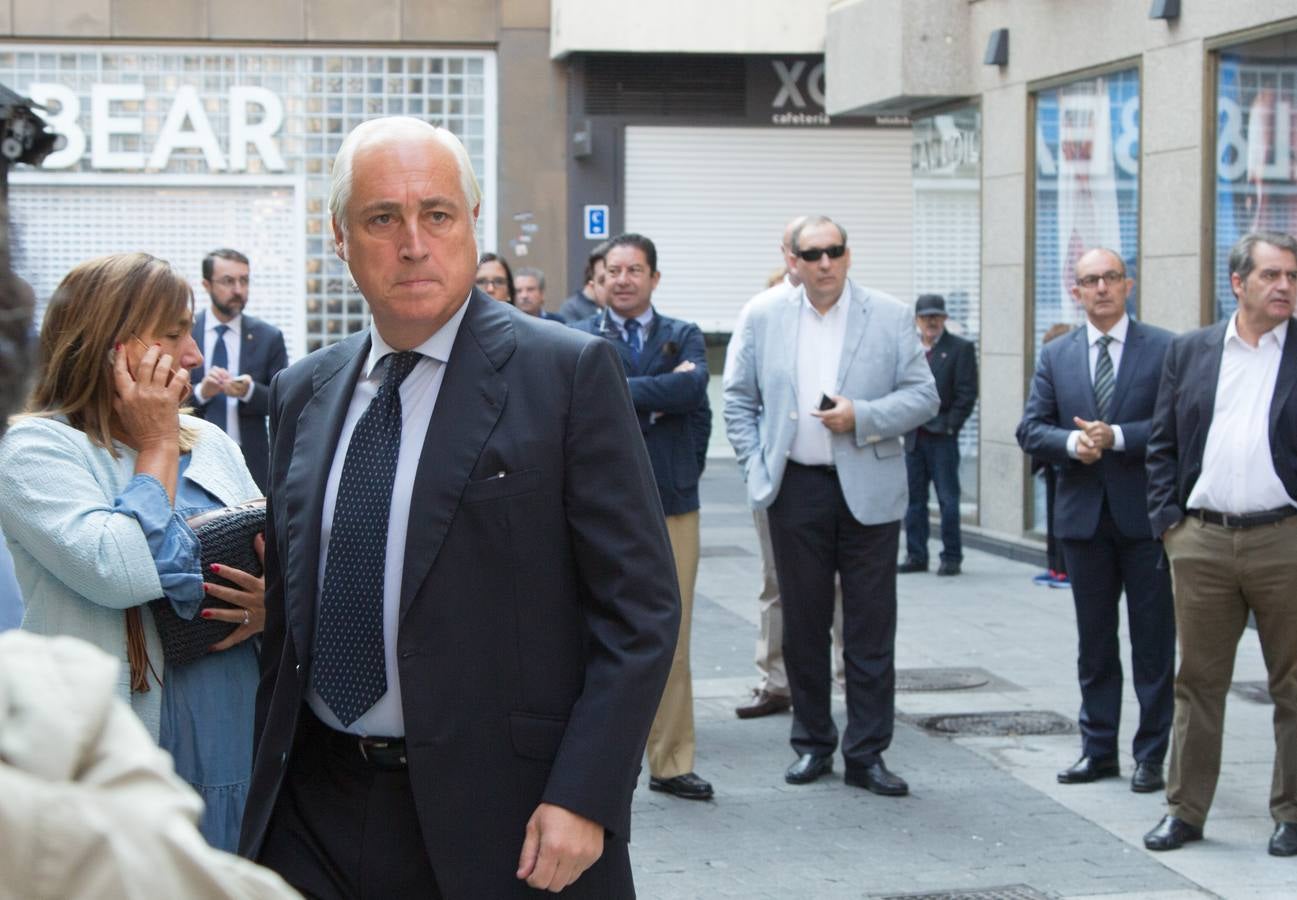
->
<box><xmin>789</xmin><ymin>288</ymin><xmax>847</xmax><ymax>466</ymax></box>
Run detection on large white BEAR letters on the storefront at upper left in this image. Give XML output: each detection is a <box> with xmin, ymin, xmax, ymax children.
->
<box><xmin>27</xmin><ymin>82</ymin><xmax>285</xmax><ymax>172</ymax></box>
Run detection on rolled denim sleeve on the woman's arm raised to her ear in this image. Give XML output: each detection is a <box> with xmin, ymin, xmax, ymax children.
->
<box><xmin>113</xmin><ymin>475</ymin><xmax>204</xmax><ymax>619</ymax></box>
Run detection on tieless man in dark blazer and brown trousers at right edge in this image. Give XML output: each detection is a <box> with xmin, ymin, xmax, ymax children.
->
<box><xmin>1144</xmin><ymin>232</ymin><xmax>1297</xmax><ymax>856</ymax></box>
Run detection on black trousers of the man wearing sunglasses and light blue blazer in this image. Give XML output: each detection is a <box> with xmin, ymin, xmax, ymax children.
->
<box><xmin>769</xmin><ymin>463</ymin><xmax>900</xmax><ymax>769</ymax></box>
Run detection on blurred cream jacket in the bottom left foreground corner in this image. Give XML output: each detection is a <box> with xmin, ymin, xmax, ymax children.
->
<box><xmin>0</xmin><ymin>632</ymin><xmax>298</xmax><ymax>900</ymax></box>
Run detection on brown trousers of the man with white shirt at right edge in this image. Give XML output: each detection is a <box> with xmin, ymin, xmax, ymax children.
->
<box><xmin>1165</xmin><ymin>516</ymin><xmax>1297</xmax><ymax>826</ymax></box>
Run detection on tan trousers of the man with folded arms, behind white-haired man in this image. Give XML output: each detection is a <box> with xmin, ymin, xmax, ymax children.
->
<box><xmin>649</xmin><ymin>510</ymin><xmax>698</xmax><ymax>778</ymax></box>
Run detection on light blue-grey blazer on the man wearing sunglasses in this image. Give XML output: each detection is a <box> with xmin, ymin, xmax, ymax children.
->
<box><xmin>725</xmin><ymin>280</ymin><xmax>940</xmax><ymax>525</ymax></box>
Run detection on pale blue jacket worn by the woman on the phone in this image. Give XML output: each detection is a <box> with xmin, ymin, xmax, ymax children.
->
<box><xmin>0</xmin><ymin>416</ymin><xmax>261</xmax><ymax>740</ymax></box>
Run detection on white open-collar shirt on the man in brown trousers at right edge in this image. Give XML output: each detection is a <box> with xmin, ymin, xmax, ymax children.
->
<box><xmin>1188</xmin><ymin>313</ymin><xmax>1297</xmax><ymax>515</ymax></box>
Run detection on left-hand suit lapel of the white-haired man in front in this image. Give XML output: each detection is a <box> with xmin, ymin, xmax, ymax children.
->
<box><xmin>280</xmin><ymin>332</ymin><xmax>370</xmax><ymax>656</ymax></box>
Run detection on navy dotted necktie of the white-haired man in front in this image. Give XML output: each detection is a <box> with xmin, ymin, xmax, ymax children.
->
<box><xmin>314</xmin><ymin>350</ymin><xmax>420</xmax><ymax>725</ymax></box>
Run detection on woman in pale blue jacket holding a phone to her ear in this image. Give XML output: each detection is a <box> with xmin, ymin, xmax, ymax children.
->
<box><xmin>0</xmin><ymin>253</ymin><xmax>265</xmax><ymax>851</ymax></box>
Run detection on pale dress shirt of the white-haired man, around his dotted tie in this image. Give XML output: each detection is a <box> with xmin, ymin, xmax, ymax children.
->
<box><xmin>306</xmin><ymin>303</ymin><xmax>468</xmax><ymax>738</ymax></box>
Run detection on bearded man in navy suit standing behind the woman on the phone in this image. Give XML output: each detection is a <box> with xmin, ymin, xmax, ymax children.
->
<box><xmin>189</xmin><ymin>249</ymin><xmax>288</xmax><ymax>493</ymax></box>
